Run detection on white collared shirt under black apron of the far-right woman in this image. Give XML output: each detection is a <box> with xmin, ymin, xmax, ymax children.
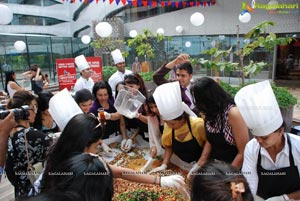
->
<box><xmin>242</xmin><ymin>133</ymin><xmax>300</xmax><ymax>195</ymax></box>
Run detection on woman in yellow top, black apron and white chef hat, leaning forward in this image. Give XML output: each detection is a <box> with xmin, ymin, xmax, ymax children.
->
<box><xmin>151</xmin><ymin>82</ymin><xmax>206</xmax><ymax>176</ymax></box>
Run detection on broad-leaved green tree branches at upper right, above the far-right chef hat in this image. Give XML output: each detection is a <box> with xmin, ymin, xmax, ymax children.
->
<box><xmin>196</xmin><ymin>21</ymin><xmax>293</xmax><ymax>85</ymax></box>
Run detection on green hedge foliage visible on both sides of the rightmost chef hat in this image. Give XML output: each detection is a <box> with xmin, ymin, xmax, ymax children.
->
<box><xmin>220</xmin><ymin>81</ymin><xmax>297</xmax><ymax>109</ymax></box>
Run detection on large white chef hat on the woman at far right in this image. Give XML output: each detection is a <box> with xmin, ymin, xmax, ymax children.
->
<box><xmin>234</xmin><ymin>80</ymin><xmax>283</xmax><ymax>136</ymax></box>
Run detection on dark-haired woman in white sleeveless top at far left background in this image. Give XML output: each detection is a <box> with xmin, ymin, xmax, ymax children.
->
<box><xmin>4</xmin><ymin>71</ymin><xmax>24</xmax><ymax>98</ymax></box>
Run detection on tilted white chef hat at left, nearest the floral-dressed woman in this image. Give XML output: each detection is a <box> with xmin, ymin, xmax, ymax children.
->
<box><xmin>49</xmin><ymin>88</ymin><xmax>83</xmax><ymax>130</ymax></box>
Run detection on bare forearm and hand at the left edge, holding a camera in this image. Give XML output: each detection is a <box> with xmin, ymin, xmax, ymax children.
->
<box><xmin>0</xmin><ymin>112</ymin><xmax>16</xmax><ymax>182</ymax></box>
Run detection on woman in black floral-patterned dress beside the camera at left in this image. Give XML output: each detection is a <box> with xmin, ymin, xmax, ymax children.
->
<box><xmin>5</xmin><ymin>91</ymin><xmax>52</xmax><ymax>198</ymax></box>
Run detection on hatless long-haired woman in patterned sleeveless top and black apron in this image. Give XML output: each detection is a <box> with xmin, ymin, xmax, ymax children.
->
<box><xmin>191</xmin><ymin>77</ymin><xmax>249</xmax><ymax>172</ymax></box>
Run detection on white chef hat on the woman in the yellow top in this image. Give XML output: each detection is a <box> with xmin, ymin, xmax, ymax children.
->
<box><xmin>153</xmin><ymin>82</ymin><xmax>183</xmax><ymax>121</ymax></box>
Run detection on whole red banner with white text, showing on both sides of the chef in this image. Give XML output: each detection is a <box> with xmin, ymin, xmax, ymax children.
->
<box><xmin>56</xmin><ymin>57</ymin><xmax>102</xmax><ymax>90</ymax></box>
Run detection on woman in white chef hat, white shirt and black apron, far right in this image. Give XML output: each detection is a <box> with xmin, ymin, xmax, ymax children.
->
<box><xmin>235</xmin><ymin>80</ymin><xmax>300</xmax><ymax>201</ymax></box>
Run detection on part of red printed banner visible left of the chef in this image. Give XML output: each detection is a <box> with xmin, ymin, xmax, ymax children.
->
<box><xmin>56</xmin><ymin>58</ymin><xmax>76</xmax><ymax>90</ymax></box>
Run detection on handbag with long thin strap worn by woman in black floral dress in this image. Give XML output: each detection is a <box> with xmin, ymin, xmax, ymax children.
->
<box><xmin>24</xmin><ymin>129</ymin><xmax>43</xmax><ymax>186</ymax></box>
